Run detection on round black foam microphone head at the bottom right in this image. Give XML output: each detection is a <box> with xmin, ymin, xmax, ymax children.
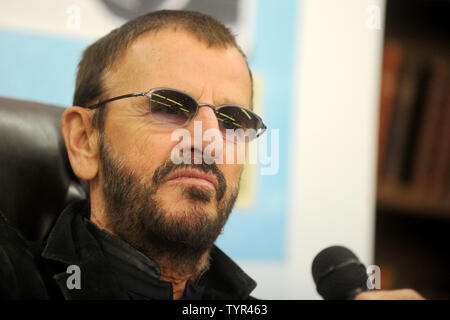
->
<box><xmin>311</xmin><ymin>246</ymin><xmax>368</xmax><ymax>300</ymax></box>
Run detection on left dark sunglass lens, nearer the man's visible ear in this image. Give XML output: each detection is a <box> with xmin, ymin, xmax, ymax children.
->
<box><xmin>149</xmin><ymin>89</ymin><xmax>197</xmax><ymax>125</ymax></box>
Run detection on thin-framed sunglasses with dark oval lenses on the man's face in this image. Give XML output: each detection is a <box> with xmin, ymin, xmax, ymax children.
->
<box><xmin>87</xmin><ymin>88</ymin><xmax>267</xmax><ymax>142</ymax></box>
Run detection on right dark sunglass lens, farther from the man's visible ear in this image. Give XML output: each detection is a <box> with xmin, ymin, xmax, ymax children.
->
<box><xmin>216</xmin><ymin>106</ymin><xmax>262</xmax><ymax>141</ymax></box>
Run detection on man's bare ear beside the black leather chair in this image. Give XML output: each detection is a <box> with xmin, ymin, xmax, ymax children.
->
<box><xmin>61</xmin><ymin>106</ymin><xmax>99</xmax><ymax>181</ymax></box>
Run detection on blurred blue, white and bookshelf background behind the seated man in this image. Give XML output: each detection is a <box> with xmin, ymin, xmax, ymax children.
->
<box><xmin>0</xmin><ymin>0</ymin><xmax>450</xmax><ymax>299</ymax></box>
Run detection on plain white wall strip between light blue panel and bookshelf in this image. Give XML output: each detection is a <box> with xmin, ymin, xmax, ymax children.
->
<box><xmin>243</xmin><ymin>0</ymin><xmax>384</xmax><ymax>299</ymax></box>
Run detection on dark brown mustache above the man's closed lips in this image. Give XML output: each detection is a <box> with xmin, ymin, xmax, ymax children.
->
<box><xmin>152</xmin><ymin>160</ymin><xmax>227</xmax><ymax>201</ymax></box>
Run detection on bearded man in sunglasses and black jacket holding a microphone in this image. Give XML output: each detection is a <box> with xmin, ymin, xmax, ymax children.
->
<box><xmin>0</xmin><ymin>11</ymin><xmax>422</xmax><ymax>299</ymax></box>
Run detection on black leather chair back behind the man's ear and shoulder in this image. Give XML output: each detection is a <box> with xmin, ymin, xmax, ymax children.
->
<box><xmin>0</xmin><ymin>97</ymin><xmax>87</xmax><ymax>240</ymax></box>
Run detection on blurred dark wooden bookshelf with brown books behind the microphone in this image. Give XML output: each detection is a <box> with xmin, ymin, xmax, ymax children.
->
<box><xmin>375</xmin><ymin>0</ymin><xmax>450</xmax><ymax>299</ymax></box>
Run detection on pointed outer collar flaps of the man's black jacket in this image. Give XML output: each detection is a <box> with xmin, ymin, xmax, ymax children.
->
<box><xmin>42</xmin><ymin>201</ymin><xmax>256</xmax><ymax>299</ymax></box>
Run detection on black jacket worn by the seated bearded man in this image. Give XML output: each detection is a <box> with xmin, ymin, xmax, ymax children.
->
<box><xmin>0</xmin><ymin>201</ymin><xmax>256</xmax><ymax>300</ymax></box>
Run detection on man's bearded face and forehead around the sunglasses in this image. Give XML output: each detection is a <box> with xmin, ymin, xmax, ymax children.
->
<box><xmin>96</xmin><ymin>30</ymin><xmax>251</xmax><ymax>262</ymax></box>
